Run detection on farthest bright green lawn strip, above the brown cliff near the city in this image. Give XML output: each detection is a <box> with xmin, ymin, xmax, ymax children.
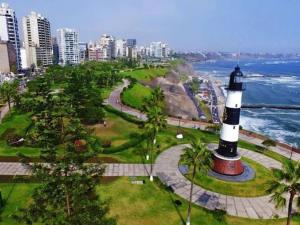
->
<box><xmin>121</xmin><ymin>68</ymin><xmax>168</xmax><ymax>81</ymax></box>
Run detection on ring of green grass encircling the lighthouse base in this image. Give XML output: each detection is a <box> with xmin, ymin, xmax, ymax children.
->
<box><xmin>187</xmin><ymin>158</ymin><xmax>272</xmax><ymax>197</ymax></box>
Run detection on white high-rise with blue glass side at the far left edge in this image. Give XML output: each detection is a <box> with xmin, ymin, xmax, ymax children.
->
<box><xmin>0</xmin><ymin>3</ymin><xmax>21</xmax><ymax>70</ymax></box>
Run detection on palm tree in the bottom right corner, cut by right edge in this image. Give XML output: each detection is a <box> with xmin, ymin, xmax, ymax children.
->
<box><xmin>267</xmin><ymin>160</ymin><xmax>300</xmax><ymax>225</ymax></box>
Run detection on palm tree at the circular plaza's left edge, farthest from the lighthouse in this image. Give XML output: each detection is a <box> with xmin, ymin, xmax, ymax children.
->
<box><xmin>145</xmin><ymin>106</ymin><xmax>167</xmax><ymax>181</ymax></box>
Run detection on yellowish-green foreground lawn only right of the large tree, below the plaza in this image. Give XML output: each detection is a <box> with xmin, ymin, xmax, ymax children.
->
<box><xmin>98</xmin><ymin>177</ymin><xmax>300</xmax><ymax>225</ymax></box>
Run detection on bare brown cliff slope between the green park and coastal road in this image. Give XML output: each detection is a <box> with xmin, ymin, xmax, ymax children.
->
<box><xmin>147</xmin><ymin>63</ymin><xmax>198</xmax><ymax>119</ymax></box>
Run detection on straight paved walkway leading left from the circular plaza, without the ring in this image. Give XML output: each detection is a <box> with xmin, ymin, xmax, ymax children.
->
<box><xmin>0</xmin><ymin>162</ymin><xmax>150</xmax><ymax>177</ymax></box>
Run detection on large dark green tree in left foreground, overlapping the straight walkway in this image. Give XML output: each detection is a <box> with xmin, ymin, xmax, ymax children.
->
<box><xmin>15</xmin><ymin>113</ymin><xmax>116</xmax><ymax>225</ymax></box>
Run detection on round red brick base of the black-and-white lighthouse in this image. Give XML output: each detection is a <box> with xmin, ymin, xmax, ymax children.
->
<box><xmin>213</xmin><ymin>152</ymin><xmax>244</xmax><ymax>176</ymax></box>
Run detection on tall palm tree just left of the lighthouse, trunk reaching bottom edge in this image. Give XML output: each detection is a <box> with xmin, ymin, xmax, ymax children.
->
<box><xmin>182</xmin><ymin>139</ymin><xmax>212</xmax><ymax>225</ymax></box>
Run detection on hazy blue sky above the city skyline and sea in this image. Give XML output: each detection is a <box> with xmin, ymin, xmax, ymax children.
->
<box><xmin>0</xmin><ymin>0</ymin><xmax>300</xmax><ymax>53</ymax></box>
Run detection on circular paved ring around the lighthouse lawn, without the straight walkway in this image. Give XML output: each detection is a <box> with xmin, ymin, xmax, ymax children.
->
<box><xmin>154</xmin><ymin>145</ymin><xmax>287</xmax><ymax>219</ymax></box>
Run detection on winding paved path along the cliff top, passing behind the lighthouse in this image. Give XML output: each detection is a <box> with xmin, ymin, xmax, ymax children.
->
<box><xmin>107</xmin><ymin>79</ymin><xmax>300</xmax><ymax>161</ymax></box>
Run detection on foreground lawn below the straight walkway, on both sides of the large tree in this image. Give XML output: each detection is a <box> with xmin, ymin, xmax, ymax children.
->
<box><xmin>0</xmin><ymin>177</ymin><xmax>300</xmax><ymax>225</ymax></box>
